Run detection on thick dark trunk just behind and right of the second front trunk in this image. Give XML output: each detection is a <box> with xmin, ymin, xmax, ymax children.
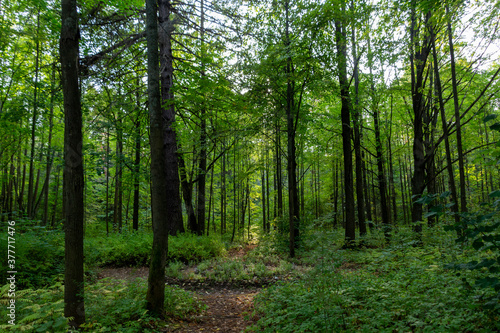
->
<box><xmin>158</xmin><ymin>0</ymin><xmax>184</xmax><ymax>235</ymax></box>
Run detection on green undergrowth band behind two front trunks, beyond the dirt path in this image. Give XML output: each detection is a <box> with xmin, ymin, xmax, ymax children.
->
<box><xmin>0</xmin><ymin>227</ymin><xmax>226</xmax><ymax>290</ymax></box>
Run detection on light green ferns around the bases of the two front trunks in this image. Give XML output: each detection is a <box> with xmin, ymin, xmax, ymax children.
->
<box><xmin>0</xmin><ymin>278</ymin><xmax>203</xmax><ymax>333</ymax></box>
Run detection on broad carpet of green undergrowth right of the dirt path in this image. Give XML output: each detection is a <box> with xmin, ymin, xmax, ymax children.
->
<box><xmin>249</xmin><ymin>226</ymin><xmax>500</xmax><ymax>332</ymax></box>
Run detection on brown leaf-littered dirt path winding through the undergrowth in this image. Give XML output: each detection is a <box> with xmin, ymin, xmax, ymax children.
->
<box><xmin>98</xmin><ymin>244</ymin><xmax>262</xmax><ymax>333</ymax></box>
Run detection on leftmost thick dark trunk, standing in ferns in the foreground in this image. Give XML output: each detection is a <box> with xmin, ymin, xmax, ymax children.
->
<box><xmin>59</xmin><ymin>0</ymin><xmax>85</xmax><ymax>328</ymax></box>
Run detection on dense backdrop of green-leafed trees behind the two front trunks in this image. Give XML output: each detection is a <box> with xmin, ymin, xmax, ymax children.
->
<box><xmin>0</xmin><ymin>0</ymin><xmax>500</xmax><ymax>327</ymax></box>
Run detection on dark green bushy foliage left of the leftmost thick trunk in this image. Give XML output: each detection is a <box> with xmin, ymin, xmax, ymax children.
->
<box><xmin>0</xmin><ymin>228</ymin><xmax>64</xmax><ymax>289</ymax></box>
